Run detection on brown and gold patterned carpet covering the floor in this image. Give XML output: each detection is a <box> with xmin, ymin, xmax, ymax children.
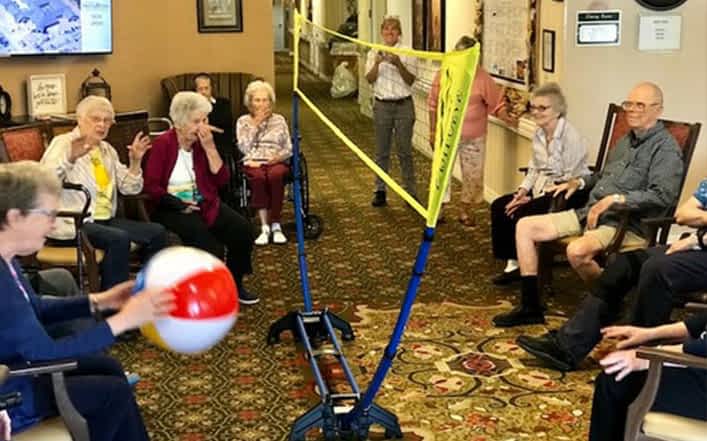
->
<box><xmin>113</xmin><ymin>56</ymin><xmax>596</xmax><ymax>441</ymax></box>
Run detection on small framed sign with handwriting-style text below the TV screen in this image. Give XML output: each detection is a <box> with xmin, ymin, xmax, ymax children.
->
<box><xmin>27</xmin><ymin>73</ymin><xmax>67</xmax><ymax>117</ymax></box>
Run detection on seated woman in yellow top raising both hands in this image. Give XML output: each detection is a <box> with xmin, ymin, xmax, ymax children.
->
<box><xmin>41</xmin><ymin>96</ymin><xmax>167</xmax><ymax>289</ymax></box>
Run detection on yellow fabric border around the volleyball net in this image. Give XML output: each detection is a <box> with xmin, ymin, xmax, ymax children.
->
<box><xmin>292</xmin><ymin>9</ymin><xmax>480</xmax><ymax>227</ymax></box>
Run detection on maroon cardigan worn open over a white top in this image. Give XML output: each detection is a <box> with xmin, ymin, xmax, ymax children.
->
<box><xmin>143</xmin><ymin>129</ymin><xmax>231</xmax><ymax>226</ymax></box>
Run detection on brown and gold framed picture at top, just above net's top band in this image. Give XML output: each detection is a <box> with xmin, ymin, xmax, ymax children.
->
<box><xmin>412</xmin><ymin>0</ymin><xmax>445</xmax><ymax>52</ymax></box>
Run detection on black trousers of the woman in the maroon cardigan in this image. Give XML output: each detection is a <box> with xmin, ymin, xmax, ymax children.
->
<box><xmin>153</xmin><ymin>203</ymin><xmax>255</xmax><ymax>281</ymax></box>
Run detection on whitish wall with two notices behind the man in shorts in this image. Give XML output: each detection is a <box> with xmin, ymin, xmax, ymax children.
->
<box><xmin>562</xmin><ymin>0</ymin><xmax>707</xmax><ymax>198</ymax></box>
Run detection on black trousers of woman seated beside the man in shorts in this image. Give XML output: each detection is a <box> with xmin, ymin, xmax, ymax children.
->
<box><xmin>491</xmin><ymin>191</ymin><xmax>588</xmax><ymax>260</ymax></box>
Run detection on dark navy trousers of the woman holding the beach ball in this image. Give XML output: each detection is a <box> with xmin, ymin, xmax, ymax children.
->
<box><xmin>35</xmin><ymin>355</ymin><xmax>149</xmax><ymax>441</ymax></box>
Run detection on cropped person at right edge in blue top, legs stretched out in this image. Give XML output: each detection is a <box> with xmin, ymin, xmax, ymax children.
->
<box><xmin>518</xmin><ymin>179</ymin><xmax>707</xmax><ymax>371</ymax></box>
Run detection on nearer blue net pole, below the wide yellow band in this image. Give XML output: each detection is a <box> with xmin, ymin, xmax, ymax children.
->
<box><xmin>349</xmin><ymin>227</ymin><xmax>435</xmax><ymax>419</ymax></box>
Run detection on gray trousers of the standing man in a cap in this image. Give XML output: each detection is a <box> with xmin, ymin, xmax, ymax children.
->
<box><xmin>373</xmin><ymin>98</ymin><xmax>417</xmax><ymax>197</ymax></box>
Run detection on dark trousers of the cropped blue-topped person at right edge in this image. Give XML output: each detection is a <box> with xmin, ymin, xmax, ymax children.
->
<box><xmin>557</xmin><ymin>247</ymin><xmax>707</xmax><ymax>361</ymax></box>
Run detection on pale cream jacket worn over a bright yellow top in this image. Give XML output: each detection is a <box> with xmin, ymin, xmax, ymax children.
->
<box><xmin>41</xmin><ymin>127</ymin><xmax>142</xmax><ymax>239</ymax></box>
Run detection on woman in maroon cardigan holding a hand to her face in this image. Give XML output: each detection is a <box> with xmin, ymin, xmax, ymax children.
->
<box><xmin>145</xmin><ymin>92</ymin><xmax>260</xmax><ymax>304</ymax></box>
